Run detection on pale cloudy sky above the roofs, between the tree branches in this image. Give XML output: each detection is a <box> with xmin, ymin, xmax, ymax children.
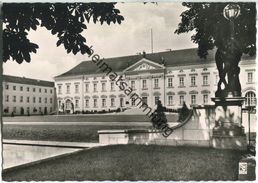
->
<box><xmin>3</xmin><ymin>3</ymin><xmax>197</xmax><ymax>81</ymax></box>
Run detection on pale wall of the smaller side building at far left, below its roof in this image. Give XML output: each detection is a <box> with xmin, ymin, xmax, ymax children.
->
<box><xmin>3</xmin><ymin>81</ymin><xmax>55</xmax><ymax>115</ymax></box>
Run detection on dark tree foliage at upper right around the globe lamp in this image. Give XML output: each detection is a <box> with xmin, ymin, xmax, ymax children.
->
<box><xmin>175</xmin><ymin>3</ymin><xmax>256</xmax><ymax>58</ymax></box>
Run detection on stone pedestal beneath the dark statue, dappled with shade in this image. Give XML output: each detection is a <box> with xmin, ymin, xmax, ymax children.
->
<box><xmin>212</xmin><ymin>97</ymin><xmax>247</xmax><ymax>150</ymax></box>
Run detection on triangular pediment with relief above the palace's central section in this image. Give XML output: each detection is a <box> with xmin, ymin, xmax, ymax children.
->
<box><xmin>124</xmin><ymin>58</ymin><xmax>164</xmax><ymax>71</ymax></box>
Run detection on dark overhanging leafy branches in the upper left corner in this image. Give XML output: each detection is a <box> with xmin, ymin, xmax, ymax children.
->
<box><xmin>2</xmin><ymin>3</ymin><xmax>124</xmax><ymax>63</ymax></box>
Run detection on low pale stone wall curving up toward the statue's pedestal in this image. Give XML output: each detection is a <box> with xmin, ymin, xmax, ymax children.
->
<box><xmin>98</xmin><ymin>107</ymin><xmax>215</xmax><ymax>147</ymax></box>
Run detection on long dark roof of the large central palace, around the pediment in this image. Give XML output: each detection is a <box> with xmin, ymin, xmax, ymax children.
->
<box><xmin>55</xmin><ymin>48</ymin><xmax>255</xmax><ymax>78</ymax></box>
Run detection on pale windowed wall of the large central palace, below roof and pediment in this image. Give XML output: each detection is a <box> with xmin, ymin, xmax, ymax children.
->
<box><xmin>55</xmin><ymin>60</ymin><xmax>256</xmax><ymax>112</ymax></box>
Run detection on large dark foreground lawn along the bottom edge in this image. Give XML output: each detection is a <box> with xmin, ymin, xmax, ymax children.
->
<box><xmin>2</xmin><ymin>145</ymin><xmax>244</xmax><ymax>181</ymax></box>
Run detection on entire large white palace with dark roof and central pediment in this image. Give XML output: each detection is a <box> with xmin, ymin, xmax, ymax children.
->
<box><xmin>55</xmin><ymin>49</ymin><xmax>256</xmax><ymax>113</ymax></box>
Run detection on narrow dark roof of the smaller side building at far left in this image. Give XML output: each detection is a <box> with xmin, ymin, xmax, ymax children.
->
<box><xmin>3</xmin><ymin>75</ymin><xmax>55</xmax><ymax>87</ymax></box>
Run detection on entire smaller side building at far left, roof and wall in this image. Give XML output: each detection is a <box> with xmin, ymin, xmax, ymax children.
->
<box><xmin>3</xmin><ymin>75</ymin><xmax>56</xmax><ymax>115</ymax></box>
